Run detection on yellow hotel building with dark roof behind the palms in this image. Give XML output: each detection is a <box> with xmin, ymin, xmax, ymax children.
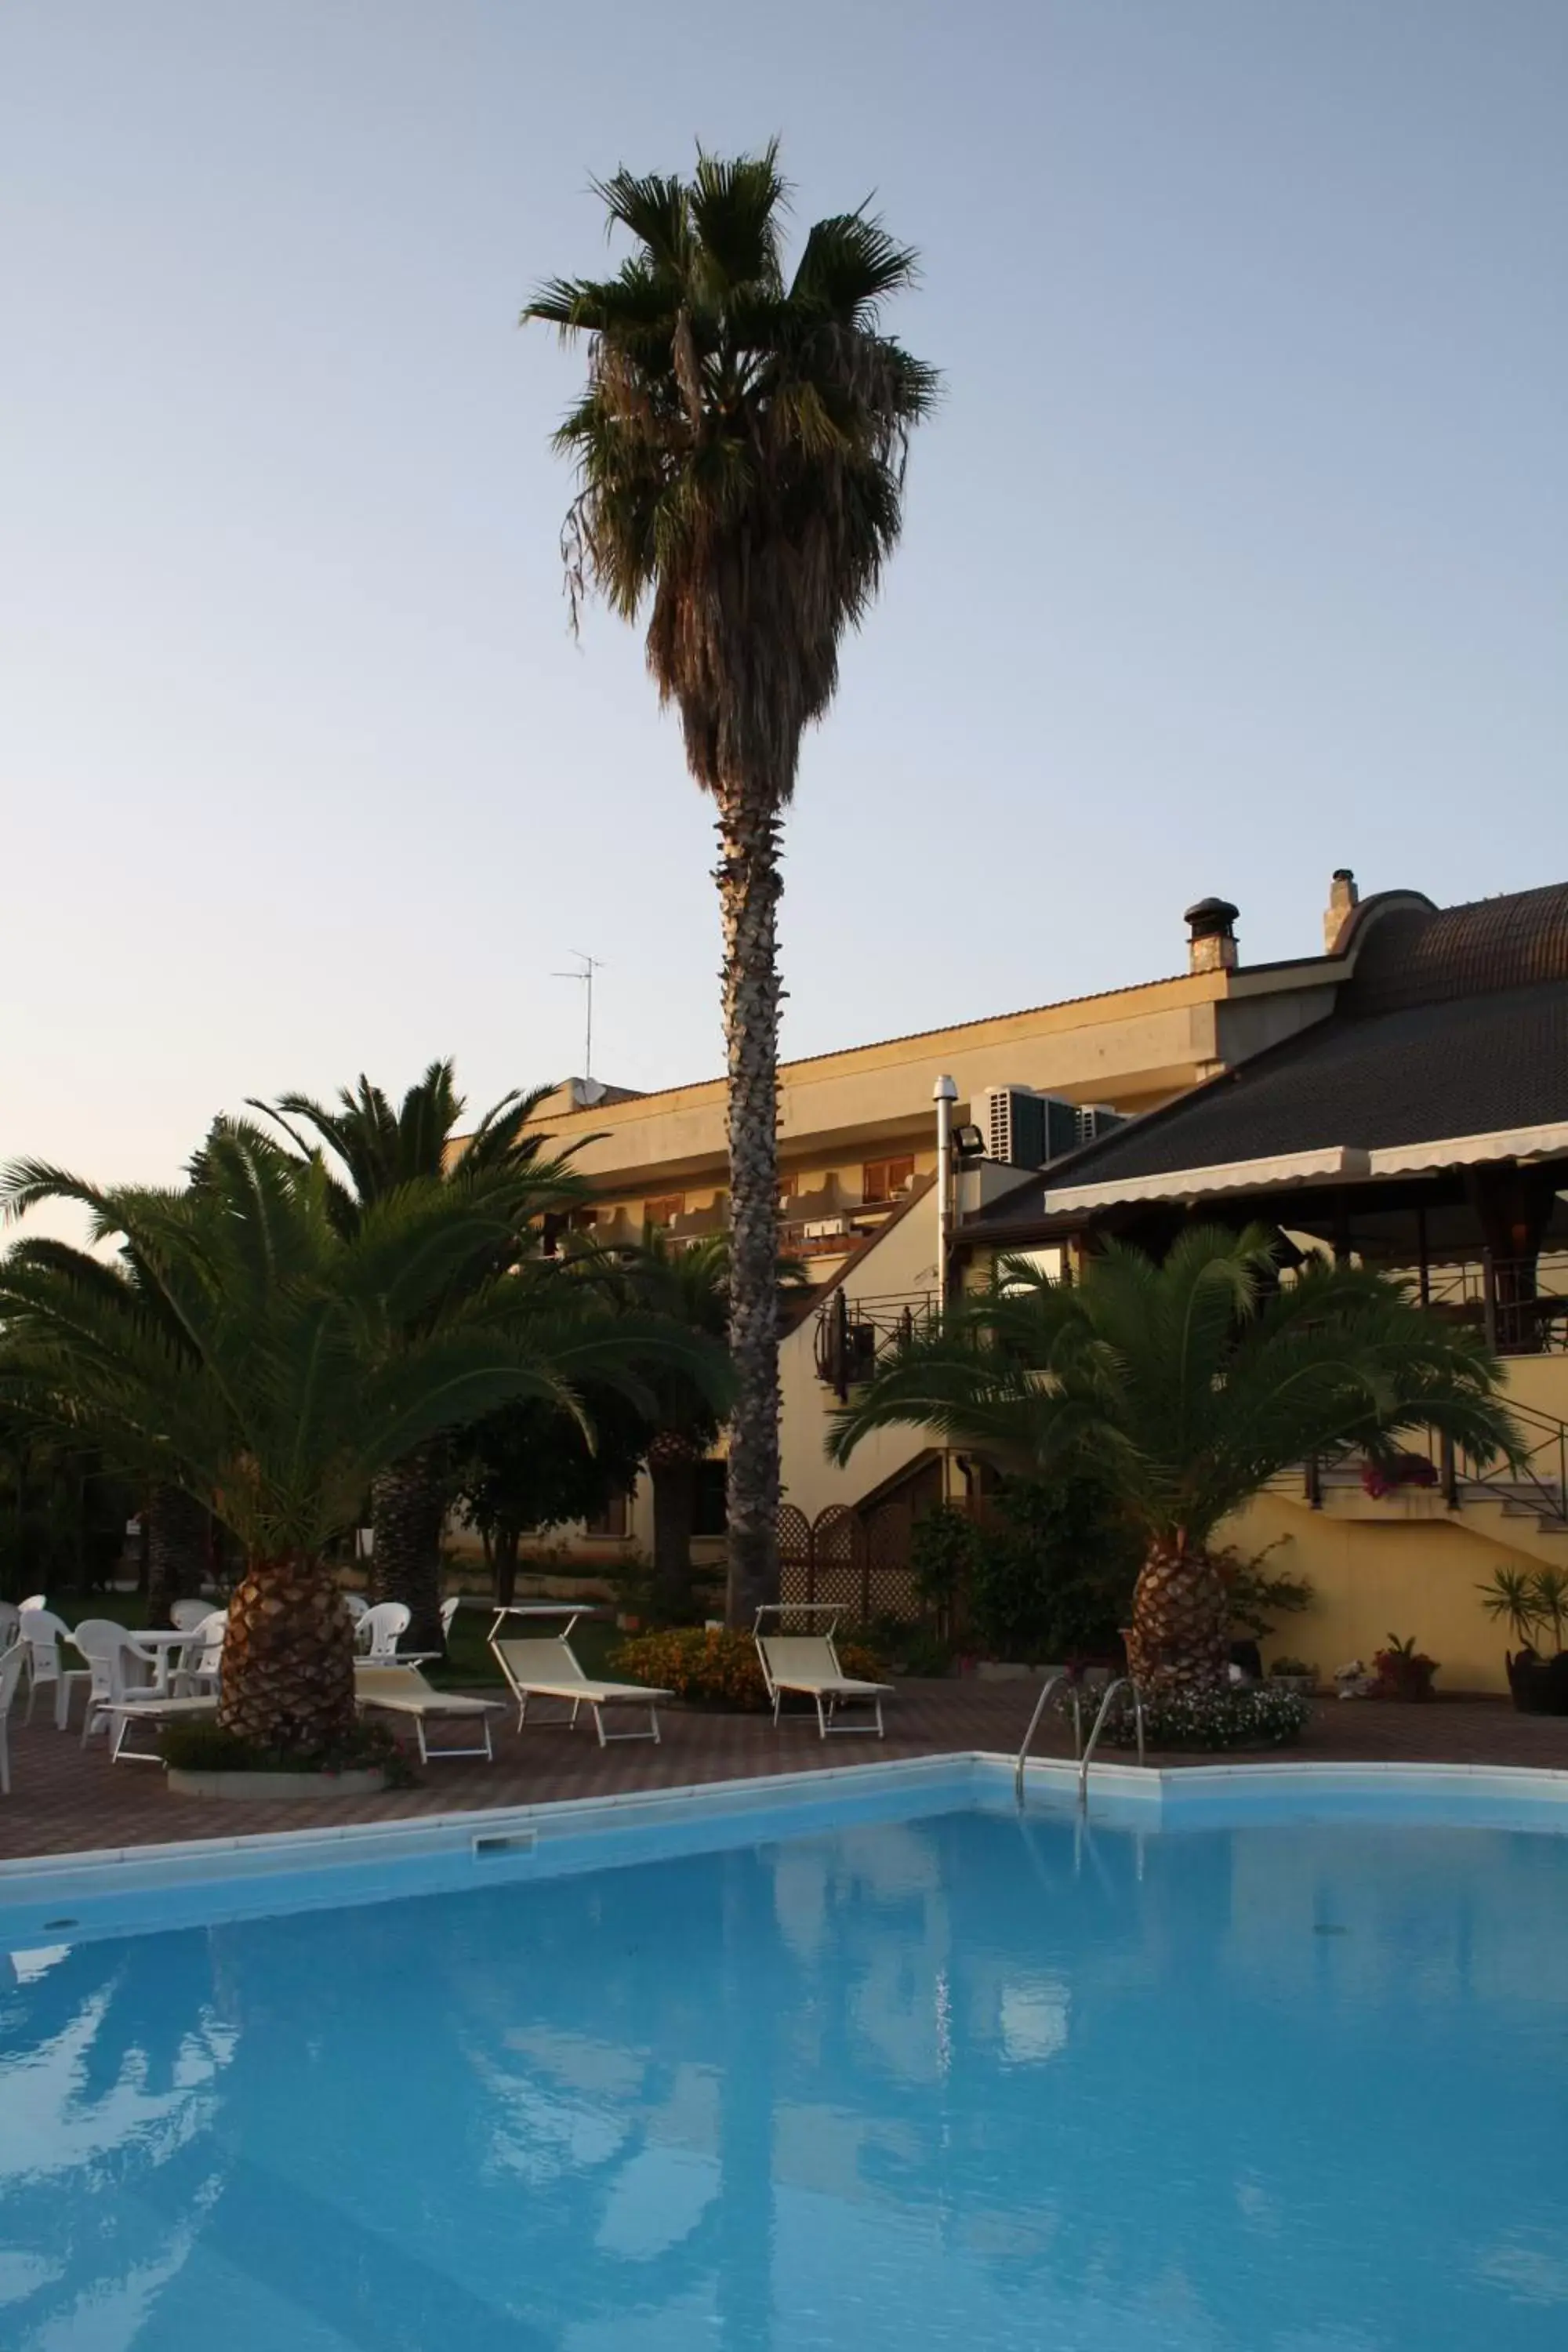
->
<box><xmin>495</xmin><ymin>873</ymin><xmax>1568</xmax><ymax>1689</ymax></box>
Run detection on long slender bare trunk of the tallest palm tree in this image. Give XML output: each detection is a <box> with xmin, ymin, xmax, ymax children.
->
<box><xmin>717</xmin><ymin>783</ymin><xmax>783</xmax><ymax>1625</ymax></box>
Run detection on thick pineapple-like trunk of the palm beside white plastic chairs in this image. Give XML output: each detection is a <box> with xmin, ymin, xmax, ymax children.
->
<box><xmin>219</xmin><ymin>1552</ymin><xmax>355</xmax><ymax>1755</ymax></box>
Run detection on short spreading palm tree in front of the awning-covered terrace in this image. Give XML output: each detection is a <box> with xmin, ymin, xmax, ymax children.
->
<box><xmin>827</xmin><ymin>1225</ymin><xmax>1519</xmax><ymax>1691</ymax></box>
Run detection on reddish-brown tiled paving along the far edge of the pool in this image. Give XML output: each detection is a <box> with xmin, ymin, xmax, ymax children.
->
<box><xmin>0</xmin><ymin>1682</ymin><xmax>1568</xmax><ymax>1858</ymax></box>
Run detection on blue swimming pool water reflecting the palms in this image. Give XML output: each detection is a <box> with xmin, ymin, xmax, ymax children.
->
<box><xmin>0</xmin><ymin>1809</ymin><xmax>1568</xmax><ymax>2352</ymax></box>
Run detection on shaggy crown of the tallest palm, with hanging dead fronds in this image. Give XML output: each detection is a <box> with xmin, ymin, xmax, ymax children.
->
<box><xmin>524</xmin><ymin>146</ymin><xmax>938</xmax><ymax>804</ymax></box>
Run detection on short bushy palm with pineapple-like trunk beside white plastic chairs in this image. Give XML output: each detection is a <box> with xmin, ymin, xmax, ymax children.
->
<box><xmin>0</xmin><ymin>1127</ymin><xmax>719</xmax><ymax>1752</ymax></box>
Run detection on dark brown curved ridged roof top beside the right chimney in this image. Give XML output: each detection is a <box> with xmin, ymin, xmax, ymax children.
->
<box><xmin>1338</xmin><ymin>882</ymin><xmax>1568</xmax><ymax>1014</ymax></box>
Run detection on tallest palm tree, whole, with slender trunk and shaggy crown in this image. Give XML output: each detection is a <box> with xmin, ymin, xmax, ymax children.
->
<box><xmin>524</xmin><ymin>146</ymin><xmax>938</xmax><ymax>1621</ymax></box>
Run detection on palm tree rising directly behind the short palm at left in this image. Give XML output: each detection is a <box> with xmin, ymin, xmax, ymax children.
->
<box><xmin>252</xmin><ymin>1061</ymin><xmax>588</xmax><ymax>1649</ymax></box>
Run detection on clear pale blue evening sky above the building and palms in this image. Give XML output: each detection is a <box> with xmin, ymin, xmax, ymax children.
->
<box><xmin>0</xmin><ymin>0</ymin><xmax>1568</xmax><ymax>1178</ymax></box>
